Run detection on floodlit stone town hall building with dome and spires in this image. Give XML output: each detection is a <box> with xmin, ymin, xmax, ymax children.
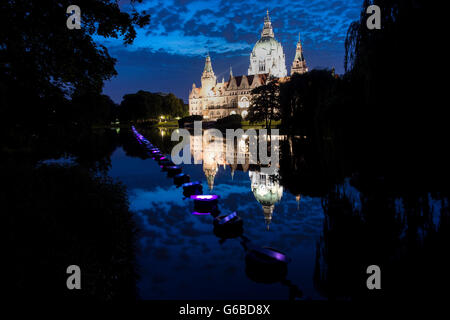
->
<box><xmin>189</xmin><ymin>12</ymin><xmax>308</xmax><ymax>120</ymax></box>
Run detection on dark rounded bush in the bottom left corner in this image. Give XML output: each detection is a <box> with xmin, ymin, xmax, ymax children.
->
<box><xmin>0</xmin><ymin>165</ymin><xmax>137</xmax><ymax>300</ymax></box>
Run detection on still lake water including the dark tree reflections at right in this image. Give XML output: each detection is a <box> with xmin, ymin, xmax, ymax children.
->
<box><xmin>106</xmin><ymin>129</ymin><xmax>450</xmax><ymax>300</ymax></box>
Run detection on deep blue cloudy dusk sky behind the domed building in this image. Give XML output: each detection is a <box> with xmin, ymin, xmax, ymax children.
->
<box><xmin>98</xmin><ymin>0</ymin><xmax>362</xmax><ymax>102</ymax></box>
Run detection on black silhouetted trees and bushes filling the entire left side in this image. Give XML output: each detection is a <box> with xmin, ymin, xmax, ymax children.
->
<box><xmin>0</xmin><ymin>0</ymin><xmax>149</xmax><ymax>300</ymax></box>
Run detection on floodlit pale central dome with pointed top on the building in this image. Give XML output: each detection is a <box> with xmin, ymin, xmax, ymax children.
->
<box><xmin>248</xmin><ymin>10</ymin><xmax>287</xmax><ymax>78</ymax></box>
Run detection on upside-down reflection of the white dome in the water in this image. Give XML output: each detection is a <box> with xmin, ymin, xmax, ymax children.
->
<box><xmin>249</xmin><ymin>170</ymin><xmax>283</xmax><ymax>230</ymax></box>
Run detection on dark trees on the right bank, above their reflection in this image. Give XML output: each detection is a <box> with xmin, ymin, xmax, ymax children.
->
<box><xmin>279</xmin><ymin>0</ymin><xmax>449</xmax><ymax>186</ymax></box>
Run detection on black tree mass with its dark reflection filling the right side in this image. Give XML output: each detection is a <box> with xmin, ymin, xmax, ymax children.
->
<box><xmin>279</xmin><ymin>0</ymin><xmax>450</xmax><ymax>301</ymax></box>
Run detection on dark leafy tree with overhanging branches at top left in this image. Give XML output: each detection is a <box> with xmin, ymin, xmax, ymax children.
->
<box><xmin>0</xmin><ymin>0</ymin><xmax>149</xmax><ymax>136</ymax></box>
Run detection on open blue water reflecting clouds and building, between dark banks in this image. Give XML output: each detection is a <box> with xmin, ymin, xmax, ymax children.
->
<box><xmin>109</xmin><ymin>131</ymin><xmax>324</xmax><ymax>299</ymax></box>
